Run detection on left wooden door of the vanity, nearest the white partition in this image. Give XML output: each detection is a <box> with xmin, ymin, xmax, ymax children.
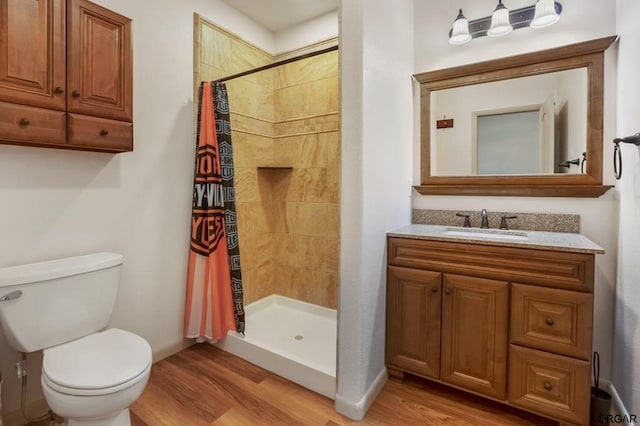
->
<box><xmin>386</xmin><ymin>266</ymin><xmax>442</xmax><ymax>378</ymax></box>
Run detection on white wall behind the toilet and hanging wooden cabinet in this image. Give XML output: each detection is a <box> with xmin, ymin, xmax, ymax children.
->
<box><xmin>0</xmin><ymin>0</ymin><xmax>273</xmax><ymax>420</ymax></box>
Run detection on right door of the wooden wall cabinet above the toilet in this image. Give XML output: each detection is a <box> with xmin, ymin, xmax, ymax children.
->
<box><xmin>66</xmin><ymin>0</ymin><xmax>133</xmax><ymax>121</ymax></box>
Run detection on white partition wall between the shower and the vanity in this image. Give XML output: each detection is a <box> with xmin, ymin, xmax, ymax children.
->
<box><xmin>336</xmin><ymin>0</ymin><xmax>413</xmax><ymax>419</ymax></box>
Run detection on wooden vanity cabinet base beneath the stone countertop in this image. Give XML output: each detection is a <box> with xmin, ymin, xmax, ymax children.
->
<box><xmin>386</xmin><ymin>237</ymin><xmax>594</xmax><ymax>425</ymax></box>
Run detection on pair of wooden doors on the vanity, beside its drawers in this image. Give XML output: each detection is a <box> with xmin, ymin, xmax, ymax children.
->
<box><xmin>386</xmin><ymin>266</ymin><xmax>509</xmax><ymax>399</ymax></box>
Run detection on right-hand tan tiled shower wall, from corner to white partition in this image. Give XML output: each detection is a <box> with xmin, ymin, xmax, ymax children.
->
<box><xmin>273</xmin><ymin>52</ymin><xmax>340</xmax><ymax>308</ymax></box>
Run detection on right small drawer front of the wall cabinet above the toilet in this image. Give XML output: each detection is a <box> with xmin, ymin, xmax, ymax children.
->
<box><xmin>68</xmin><ymin>114</ymin><xmax>133</xmax><ymax>152</ymax></box>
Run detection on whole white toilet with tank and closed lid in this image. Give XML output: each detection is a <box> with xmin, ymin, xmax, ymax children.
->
<box><xmin>0</xmin><ymin>253</ymin><xmax>151</xmax><ymax>426</ymax></box>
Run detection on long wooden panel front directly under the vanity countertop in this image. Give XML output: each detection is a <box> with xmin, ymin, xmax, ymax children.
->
<box><xmin>387</xmin><ymin>237</ymin><xmax>594</xmax><ymax>292</ymax></box>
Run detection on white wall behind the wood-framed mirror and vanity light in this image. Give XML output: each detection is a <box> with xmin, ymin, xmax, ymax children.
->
<box><xmin>413</xmin><ymin>0</ymin><xmax>616</xmax><ymax>379</ymax></box>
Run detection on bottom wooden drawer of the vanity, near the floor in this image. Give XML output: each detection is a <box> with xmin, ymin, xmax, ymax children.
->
<box><xmin>508</xmin><ymin>345</ymin><xmax>591</xmax><ymax>425</ymax></box>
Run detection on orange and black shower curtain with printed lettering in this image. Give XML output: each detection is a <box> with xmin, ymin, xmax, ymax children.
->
<box><xmin>185</xmin><ymin>82</ymin><xmax>245</xmax><ymax>341</ymax></box>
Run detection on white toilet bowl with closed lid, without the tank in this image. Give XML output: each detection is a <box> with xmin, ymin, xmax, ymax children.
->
<box><xmin>41</xmin><ymin>328</ymin><xmax>152</xmax><ymax>426</ymax></box>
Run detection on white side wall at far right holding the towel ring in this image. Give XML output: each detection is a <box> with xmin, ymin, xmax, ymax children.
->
<box><xmin>612</xmin><ymin>0</ymin><xmax>640</xmax><ymax>414</ymax></box>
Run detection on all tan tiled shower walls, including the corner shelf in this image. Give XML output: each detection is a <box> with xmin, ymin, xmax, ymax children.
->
<box><xmin>195</xmin><ymin>22</ymin><xmax>340</xmax><ymax>308</ymax></box>
